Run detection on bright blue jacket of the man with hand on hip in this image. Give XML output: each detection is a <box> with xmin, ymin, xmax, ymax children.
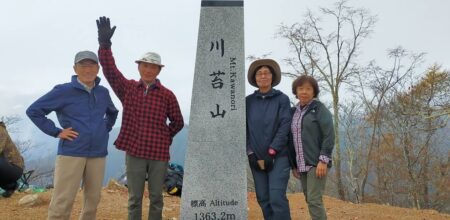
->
<box><xmin>27</xmin><ymin>75</ymin><xmax>119</xmax><ymax>157</ymax></box>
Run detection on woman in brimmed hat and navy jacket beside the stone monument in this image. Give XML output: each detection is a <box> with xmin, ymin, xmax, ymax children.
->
<box><xmin>246</xmin><ymin>59</ymin><xmax>291</xmax><ymax>220</ymax></box>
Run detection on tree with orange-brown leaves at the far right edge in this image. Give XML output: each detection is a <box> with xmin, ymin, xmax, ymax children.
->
<box><xmin>387</xmin><ymin>66</ymin><xmax>450</xmax><ymax>209</ymax></box>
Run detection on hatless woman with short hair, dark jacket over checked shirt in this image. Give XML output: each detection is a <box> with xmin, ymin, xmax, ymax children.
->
<box><xmin>289</xmin><ymin>76</ymin><xmax>334</xmax><ymax>220</ymax></box>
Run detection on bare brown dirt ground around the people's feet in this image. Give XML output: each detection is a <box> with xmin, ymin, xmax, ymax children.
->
<box><xmin>0</xmin><ymin>184</ymin><xmax>450</xmax><ymax>220</ymax></box>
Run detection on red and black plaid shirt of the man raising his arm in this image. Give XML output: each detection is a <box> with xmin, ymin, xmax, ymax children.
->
<box><xmin>98</xmin><ymin>47</ymin><xmax>184</xmax><ymax>161</ymax></box>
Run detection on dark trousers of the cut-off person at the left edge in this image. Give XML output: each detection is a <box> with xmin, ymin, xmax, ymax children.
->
<box><xmin>0</xmin><ymin>156</ymin><xmax>23</xmax><ymax>191</ymax></box>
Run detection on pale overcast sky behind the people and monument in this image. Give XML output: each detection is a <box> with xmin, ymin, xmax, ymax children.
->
<box><xmin>0</xmin><ymin>0</ymin><xmax>450</xmax><ymax>136</ymax></box>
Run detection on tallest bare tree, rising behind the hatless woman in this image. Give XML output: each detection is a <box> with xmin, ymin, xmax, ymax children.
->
<box><xmin>278</xmin><ymin>0</ymin><xmax>376</xmax><ymax>199</ymax></box>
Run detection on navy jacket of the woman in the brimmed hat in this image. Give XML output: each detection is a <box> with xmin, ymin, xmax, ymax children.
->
<box><xmin>246</xmin><ymin>89</ymin><xmax>292</xmax><ymax>159</ymax></box>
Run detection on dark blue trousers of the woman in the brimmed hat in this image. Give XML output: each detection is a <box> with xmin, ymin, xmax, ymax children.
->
<box><xmin>250</xmin><ymin>157</ymin><xmax>291</xmax><ymax>220</ymax></box>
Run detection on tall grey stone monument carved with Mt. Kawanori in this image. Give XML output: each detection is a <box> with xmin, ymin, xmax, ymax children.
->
<box><xmin>180</xmin><ymin>0</ymin><xmax>248</xmax><ymax>220</ymax></box>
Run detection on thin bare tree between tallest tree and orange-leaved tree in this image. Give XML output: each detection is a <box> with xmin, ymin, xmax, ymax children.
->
<box><xmin>355</xmin><ymin>47</ymin><xmax>424</xmax><ymax>200</ymax></box>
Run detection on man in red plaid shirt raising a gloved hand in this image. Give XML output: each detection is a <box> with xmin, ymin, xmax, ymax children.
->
<box><xmin>97</xmin><ymin>17</ymin><xmax>184</xmax><ymax>220</ymax></box>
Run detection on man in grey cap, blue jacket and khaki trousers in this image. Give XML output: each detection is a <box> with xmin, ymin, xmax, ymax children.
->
<box><xmin>27</xmin><ymin>51</ymin><xmax>118</xmax><ymax>219</ymax></box>
